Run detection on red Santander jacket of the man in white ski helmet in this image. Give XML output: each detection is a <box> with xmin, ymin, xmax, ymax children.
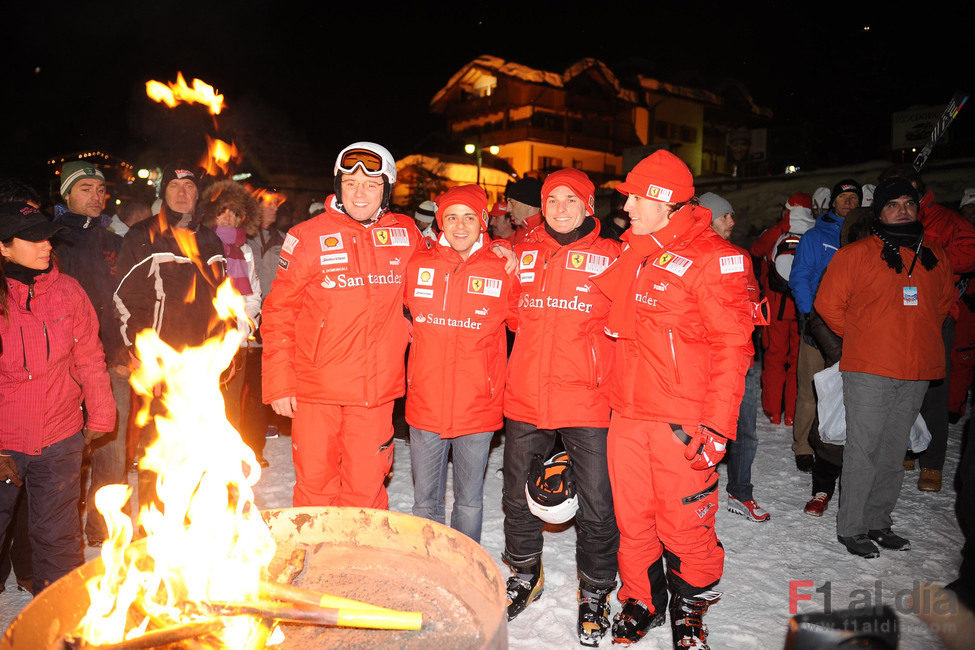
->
<box><xmin>261</xmin><ymin>196</ymin><xmax>424</xmax><ymax>407</ymax></box>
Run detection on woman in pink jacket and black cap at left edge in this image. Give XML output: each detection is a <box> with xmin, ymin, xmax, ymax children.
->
<box><xmin>0</xmin><ymin>203</ymin><xmax>115</xmax><ymax>593</ymax></box>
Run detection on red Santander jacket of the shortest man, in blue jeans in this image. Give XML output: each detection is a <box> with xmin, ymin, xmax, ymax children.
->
<box><xmin>404</xmin><ymin>235</ymin><xmax>515</xmax><ymax>438</ymax></box>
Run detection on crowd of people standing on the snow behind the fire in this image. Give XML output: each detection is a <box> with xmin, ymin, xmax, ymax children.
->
<box><xmin>0</xmin><ymin>142</ymin><xmax>975</xmax><ymax>648</ymax></box>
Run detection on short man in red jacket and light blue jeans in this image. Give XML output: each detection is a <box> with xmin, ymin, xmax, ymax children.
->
<box><xmin>404</xmin><ymin>185</ymin><xmax>515</xmax><ymax>542</ymax></box>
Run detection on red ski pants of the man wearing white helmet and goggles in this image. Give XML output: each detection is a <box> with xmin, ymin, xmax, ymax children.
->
<box><xmin>291</xmin><ymin>402</ymin><xmax>393</xmax><ymax>510</ymax></box>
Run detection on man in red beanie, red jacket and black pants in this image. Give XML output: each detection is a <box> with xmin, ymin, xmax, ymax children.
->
<box><xmin>502</xmin><ymin>169</ymin><xmax>619</xmax><ymax>645</ymax></box>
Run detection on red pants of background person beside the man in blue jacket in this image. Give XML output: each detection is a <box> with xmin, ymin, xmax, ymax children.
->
<box><xmin>762</xmin><ymin>314</ymin><xmax>799</xmax><ymax>421</ymax></box>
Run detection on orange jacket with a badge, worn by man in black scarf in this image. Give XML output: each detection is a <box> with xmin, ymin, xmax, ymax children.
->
<box><xmin>815</xmin><ymin>235</ymin><xmax>955</xmax><ymax>379</ymax></box>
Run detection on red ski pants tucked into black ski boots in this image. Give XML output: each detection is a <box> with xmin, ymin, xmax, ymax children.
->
<box><xmin>607</xmin><ymin>413</ymin><xmax>724</xmax><ymax>607</ymax></box>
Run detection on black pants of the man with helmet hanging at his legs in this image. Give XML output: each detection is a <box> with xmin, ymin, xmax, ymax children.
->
<box><xmin>502</xmin><ymin>420</ymin><xmax>620</xmax><ymax>588</ymax></box>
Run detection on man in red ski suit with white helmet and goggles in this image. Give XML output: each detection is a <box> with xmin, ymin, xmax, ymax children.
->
<box><xmin>262</xmin><ymin>142</ymin><xmax>423</xmax><ymax>508</ymax></box>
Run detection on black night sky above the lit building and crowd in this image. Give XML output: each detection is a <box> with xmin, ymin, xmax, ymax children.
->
<box><xmin>0</xmin><ymin>2</ymin><xmax>975</xmax><ymax>185</ymax></box>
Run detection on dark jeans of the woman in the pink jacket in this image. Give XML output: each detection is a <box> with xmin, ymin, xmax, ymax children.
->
<box><xmin>0</xmin><ymin>431</ymin><xmax>85</xmax><ymax>594</ymax></box>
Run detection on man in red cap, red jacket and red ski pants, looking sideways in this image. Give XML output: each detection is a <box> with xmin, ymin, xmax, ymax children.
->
<box><xmin>594</xmin><ymin>151</ymin><xmax>752</xmax><ymax>647</ymax></box>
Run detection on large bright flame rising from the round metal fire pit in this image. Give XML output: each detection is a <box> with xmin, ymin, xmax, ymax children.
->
<box><xmin>78</xmin><ymin>280</ymin><xmax>275</xmax><ymax>648</ymax></box>
